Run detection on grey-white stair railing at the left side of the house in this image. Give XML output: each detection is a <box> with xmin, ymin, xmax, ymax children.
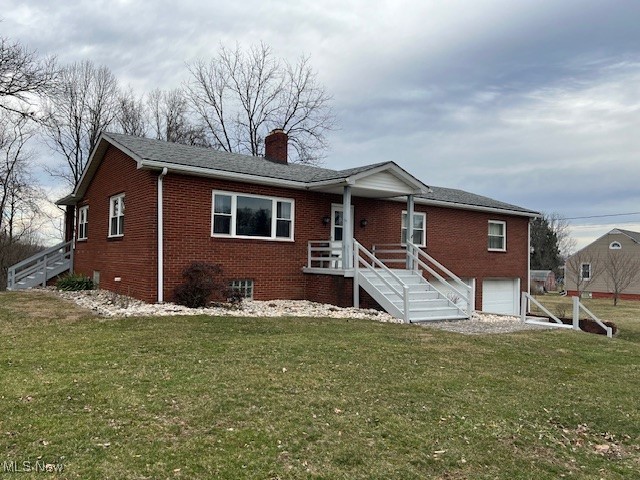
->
<box><xmin>7</xmin><ymin>241</ymin><xmax>73</xmax><ymax>290</ymax></box>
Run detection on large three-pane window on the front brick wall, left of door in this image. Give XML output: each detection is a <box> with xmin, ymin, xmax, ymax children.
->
<box><xmin>211</xmin><ymin>192</ymin><xmax>294</xmax><ymax>240</ymax></box>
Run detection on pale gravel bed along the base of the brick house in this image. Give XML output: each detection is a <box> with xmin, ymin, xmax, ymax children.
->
<box><xmin>52</xmin><ymin>290</ymin><xmax>545</xmax><ymax>335</ymax></box>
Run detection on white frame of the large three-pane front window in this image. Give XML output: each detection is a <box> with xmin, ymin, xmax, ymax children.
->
<box><xmin>211</xmin><ymin>190</ymin><xmax>296</xmax><ymax>242</ymax></box>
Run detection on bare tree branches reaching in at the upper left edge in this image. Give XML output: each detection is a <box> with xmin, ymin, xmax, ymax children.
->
<box><xmin>0</xmin><ymin>37</ymin><xmax>56</xmax><ymax>117</ymax></box>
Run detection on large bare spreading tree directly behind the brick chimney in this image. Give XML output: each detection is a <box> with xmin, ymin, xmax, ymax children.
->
<box><xmin>186</xmin><ymin>44</ymin><xmax>334</xmax><ymax>163</ymax></box>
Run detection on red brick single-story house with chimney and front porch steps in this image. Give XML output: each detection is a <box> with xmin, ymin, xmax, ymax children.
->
<box><xmin>48</xmin><ymin>130</ymin><xmax>537</xmax><ymax>321</ymax></box>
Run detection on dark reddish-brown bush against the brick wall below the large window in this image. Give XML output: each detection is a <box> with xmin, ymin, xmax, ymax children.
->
<box><xmin>174</xmin><ymin>262</ymin><xmax>231</xmax><ymax>308</ymax></box>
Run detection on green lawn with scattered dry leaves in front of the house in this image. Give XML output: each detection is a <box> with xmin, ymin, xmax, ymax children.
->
<box><xmin>0</xmin><ymin>293</ymin><xmax>640</xmax><ymax>479</ymax></box>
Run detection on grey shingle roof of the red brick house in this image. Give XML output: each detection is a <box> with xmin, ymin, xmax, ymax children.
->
<box><xmin>104</xmin><ymin>133</ymin><xmax>537</xmax><ymax>215</ymax></box>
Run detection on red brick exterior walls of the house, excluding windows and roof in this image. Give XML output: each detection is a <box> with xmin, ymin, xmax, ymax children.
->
<box><xmin>76</xmin><ymin>147</ymin><xmax>528</xmax><ymax>308</ymax></box>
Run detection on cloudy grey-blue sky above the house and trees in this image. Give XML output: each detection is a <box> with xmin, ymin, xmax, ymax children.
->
<box><xmin>0</xmin><ymin>0</ymin><xmax>640</xmax><ymax>246</ymax></box>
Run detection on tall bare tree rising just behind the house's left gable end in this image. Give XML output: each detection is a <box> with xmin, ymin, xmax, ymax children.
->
<box><xmin>44</xmin><ymin>61</ymin><xmax>119</xmax><ymax>187</ymax></box>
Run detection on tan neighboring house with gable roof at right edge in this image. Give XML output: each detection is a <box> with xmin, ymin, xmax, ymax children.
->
<box><xmin>564</xmin><ymin>228</ymin><xmax>640</xmax><ymax>300</ymax></box>
